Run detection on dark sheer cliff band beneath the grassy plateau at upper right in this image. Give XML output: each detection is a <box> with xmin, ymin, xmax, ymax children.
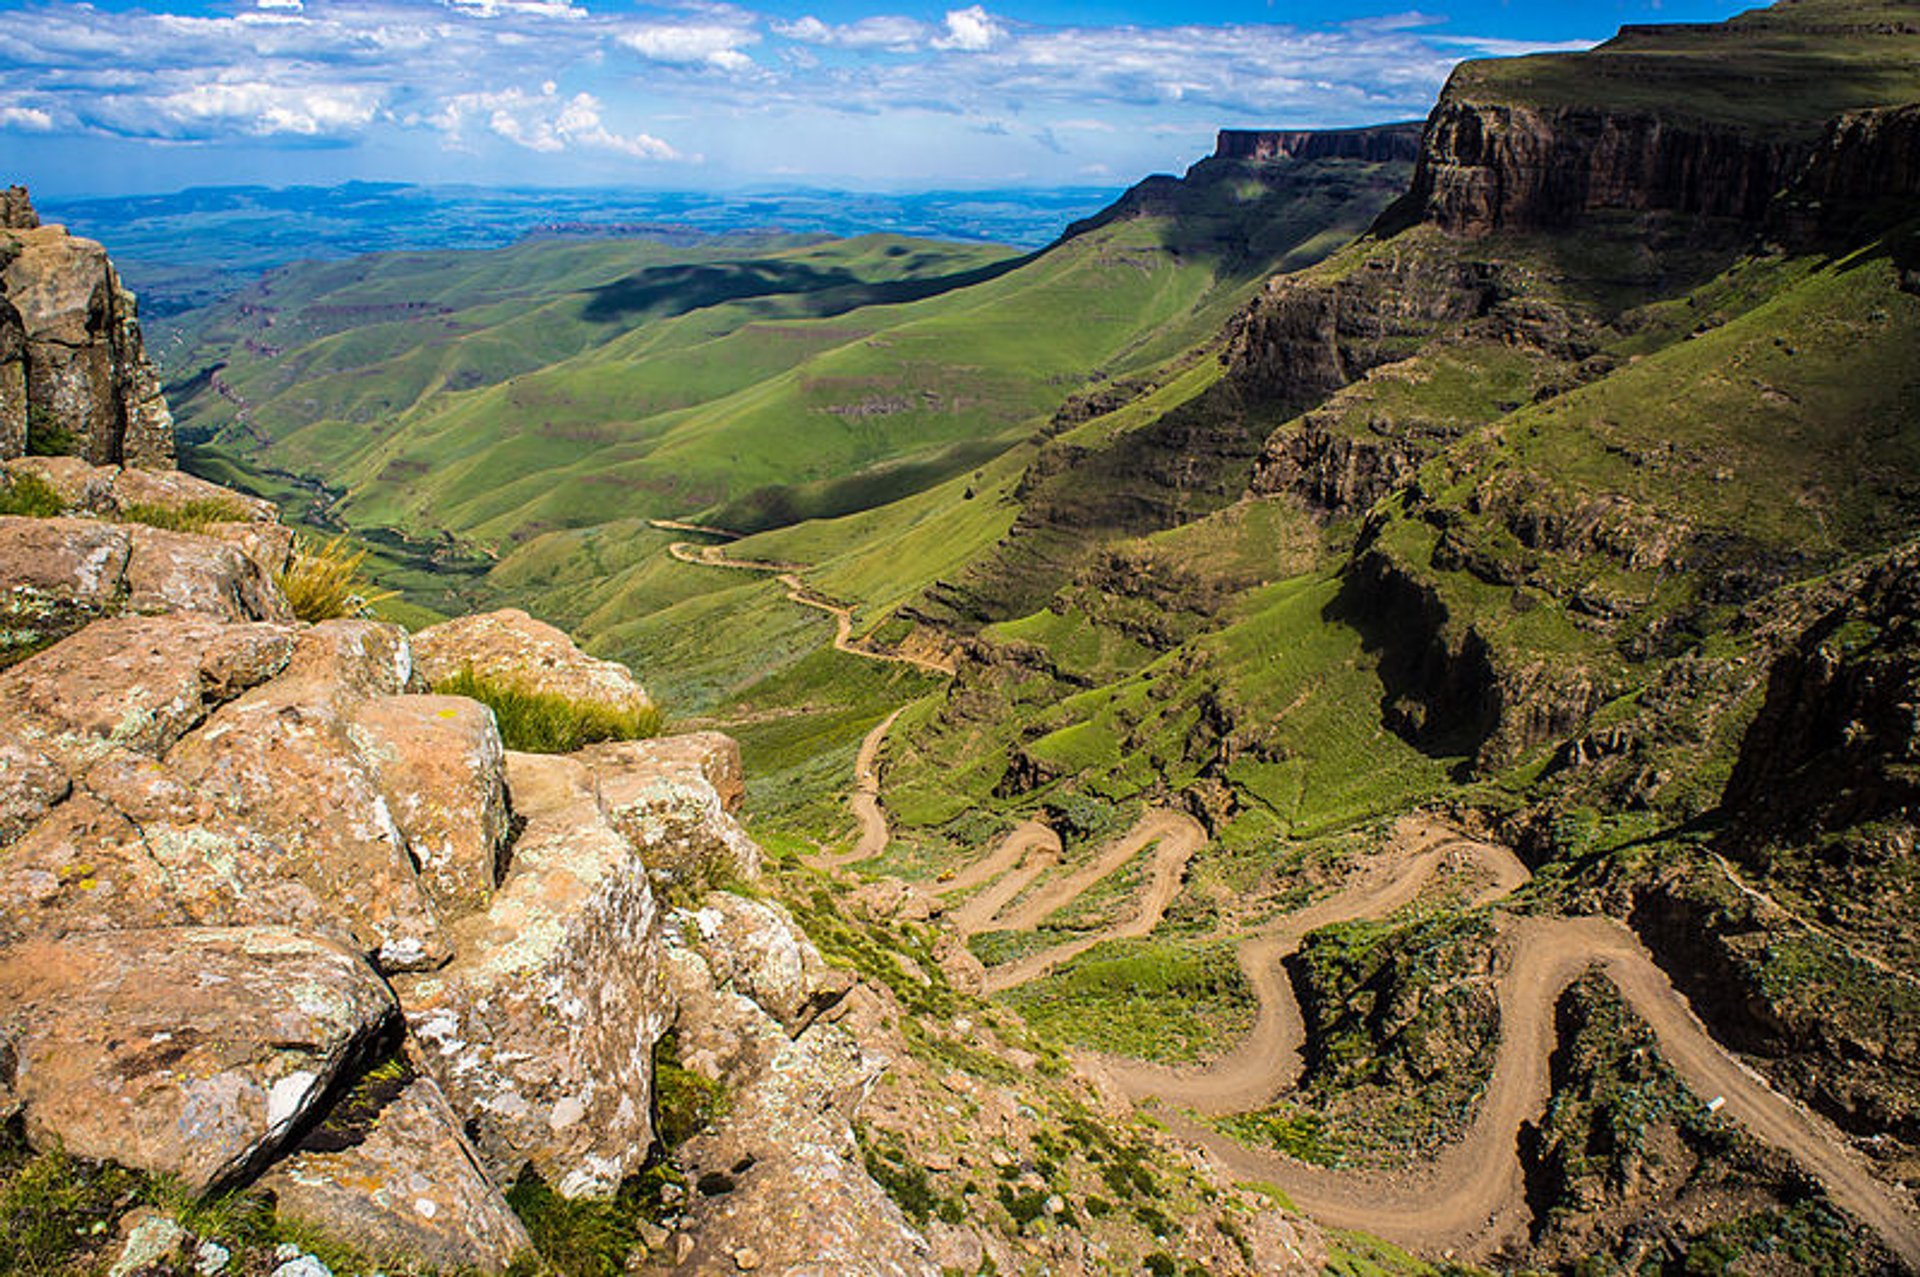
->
<box><xmin>1404</xmin><ymin>96</ymin><xmax>1809</xmax><ymax>234</ymax></box>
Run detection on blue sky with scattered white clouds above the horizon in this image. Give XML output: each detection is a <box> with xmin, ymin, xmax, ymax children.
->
<box><xmin>0</xmin><ymin>0</ymin><xmax>1749</xmax><ymax>196</ymax></box>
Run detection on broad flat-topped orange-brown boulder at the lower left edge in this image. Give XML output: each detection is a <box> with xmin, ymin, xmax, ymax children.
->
<box><xmin>0</xmin><ymin>928</ymin><xmax>394</xmax><ymax>1191</ymax></box>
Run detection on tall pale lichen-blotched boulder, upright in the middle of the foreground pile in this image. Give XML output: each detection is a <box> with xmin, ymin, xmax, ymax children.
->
<box><xmin>397</xmin><ymin>753</ymin><xmax>668</xmax><ymax>1196</ymax></box>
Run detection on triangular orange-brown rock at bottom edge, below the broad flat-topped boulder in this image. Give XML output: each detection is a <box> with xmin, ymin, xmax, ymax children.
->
<box><xmin>261</xmin><ymin>1077</ymin><xmax>532</xmax><ymax>1273</ymax></box>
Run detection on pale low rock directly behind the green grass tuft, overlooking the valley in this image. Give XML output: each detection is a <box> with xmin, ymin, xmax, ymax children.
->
<box><xmin>413</xmin><ymin>607</ymin><xmax>653</xmax><ymax>711</ymax></box>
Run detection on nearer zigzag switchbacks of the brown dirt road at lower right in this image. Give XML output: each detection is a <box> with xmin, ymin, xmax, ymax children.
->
<box><xmin>950</xmin><ymin>810</ymin><xmax>1920</xmax><ymax>1269</ymax></box>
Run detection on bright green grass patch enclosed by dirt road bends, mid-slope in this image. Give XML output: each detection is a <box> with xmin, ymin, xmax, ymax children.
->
<box><xmin>1002</xmin><ymin>939</ymin><xmax>1256</xmax><ymax>1064</ymax></box>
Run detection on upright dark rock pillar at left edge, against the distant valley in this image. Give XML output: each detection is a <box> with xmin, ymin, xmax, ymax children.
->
<box><xmin>0</xmin><ymin>186</ymin><xmax>173</xmax><ymax>467</ymax></box>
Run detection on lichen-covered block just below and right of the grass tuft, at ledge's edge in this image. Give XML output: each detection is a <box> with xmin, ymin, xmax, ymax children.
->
<box><xmin>576</xmin><ymin>732</ymin><xmax>760</xmax><ymax>883</ymax></box>
